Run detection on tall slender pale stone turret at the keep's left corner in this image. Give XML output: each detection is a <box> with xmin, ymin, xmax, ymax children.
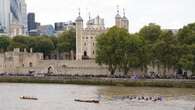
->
<box><xmin>76</xmin><ymin>9</ymin><xmax>83</xmax><ymax>60</ymax></box>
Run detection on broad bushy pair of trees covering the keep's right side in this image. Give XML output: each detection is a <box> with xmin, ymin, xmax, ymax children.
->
<box><xmin>96</xmin><ymin>27</ymin><xmax>147</xmax><ymax>75</ymax></box>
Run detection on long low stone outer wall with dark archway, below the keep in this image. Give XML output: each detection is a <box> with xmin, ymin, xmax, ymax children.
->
<box><xmin>1</xmin><ymin>60</ymin><xmax>109</xmax><ymax>75</ymax></box>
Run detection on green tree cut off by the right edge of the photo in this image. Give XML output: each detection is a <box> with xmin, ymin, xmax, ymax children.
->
<box><xmin>177</xmin><ymin>23</ymin><xmax>195</xmax><ymax>73</ymax></box>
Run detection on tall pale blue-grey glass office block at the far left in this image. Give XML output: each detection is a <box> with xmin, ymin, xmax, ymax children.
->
<box><xmin>0</xmin><ymin>0</ymin><xmax>26</xmax><ymax>37</ymax></box>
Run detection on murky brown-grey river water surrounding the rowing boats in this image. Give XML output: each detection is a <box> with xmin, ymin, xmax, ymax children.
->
<box><xmin>0</xmin><ymin>83</ymin><xmax>195</xmax><ymax>110</ymax></box>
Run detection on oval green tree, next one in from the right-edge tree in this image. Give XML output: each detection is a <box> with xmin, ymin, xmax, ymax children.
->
<box><xmin>153</xmin><ymin>31</ymin><xmax>180</xmax><ymax>74</ymax></box>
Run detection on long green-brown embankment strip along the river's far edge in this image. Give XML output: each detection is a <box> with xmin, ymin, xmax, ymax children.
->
<box><xmin>0</xmin><ymin>77</ymin><xmax>195</xmax><ymax>88</ymax></box>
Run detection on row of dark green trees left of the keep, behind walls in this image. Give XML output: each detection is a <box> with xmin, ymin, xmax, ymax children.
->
<box><xmin>0</xmin><ymin>29</ymin><xmax>76</xmax><ymax>56</ymax></box>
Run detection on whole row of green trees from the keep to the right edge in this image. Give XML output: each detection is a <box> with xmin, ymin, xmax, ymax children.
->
<box><xmin>96</xmin><ymin>23</ymin><xmax>195</xmax><ymax>74</ymax></box>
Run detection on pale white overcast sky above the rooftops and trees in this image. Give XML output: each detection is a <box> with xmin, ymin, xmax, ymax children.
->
<box><xmin>26</xmin><ymin>0</ymin><xmax>195</xmax><ymax>32</ymax></box>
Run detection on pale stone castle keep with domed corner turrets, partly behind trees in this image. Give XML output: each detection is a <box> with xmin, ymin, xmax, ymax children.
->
<box><xmin>75</xmin><ymin>10</ymin><xmax>129</xmax><ymax>60</ymax></box>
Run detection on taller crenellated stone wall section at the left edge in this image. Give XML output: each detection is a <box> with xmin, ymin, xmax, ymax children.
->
<box><xmin>0</xmin><ymin>49</ymin><xmax>43</xmax><ymax>73</ymax></box>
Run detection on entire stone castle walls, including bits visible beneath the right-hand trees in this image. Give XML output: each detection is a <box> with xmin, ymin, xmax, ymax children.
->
<box><xmin>0</xmin><ymin>49</ymin><xmax>180</xmax><ymax>75</ymax></box>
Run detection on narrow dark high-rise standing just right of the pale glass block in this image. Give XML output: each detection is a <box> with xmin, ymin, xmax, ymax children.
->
<box><xmin>27</xmin><ymin>13</ymin><xmax>36</xmax><ymax>32</ymax></box>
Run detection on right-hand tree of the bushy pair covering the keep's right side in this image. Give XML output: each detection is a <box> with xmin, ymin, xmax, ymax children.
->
<box><xmin>120</xmin><ymin>35</ymin><xmax>148</xmax><ymax>75</ymax></box>
